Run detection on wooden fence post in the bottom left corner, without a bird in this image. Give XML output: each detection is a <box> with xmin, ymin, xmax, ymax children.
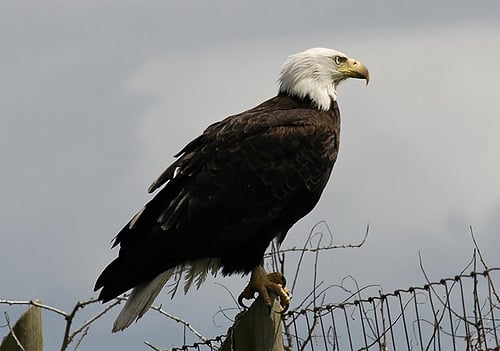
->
<box><xmin>0</xmin><ymin>306</ymin><xmax>43</xmax><ymax>351</ymax></box>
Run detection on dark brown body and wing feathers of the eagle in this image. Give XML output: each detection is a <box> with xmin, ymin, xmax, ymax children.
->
<box><xmin>95</xmin><ymin>94</ymin><xmax>340</xmax><ymax>301</ymax></box>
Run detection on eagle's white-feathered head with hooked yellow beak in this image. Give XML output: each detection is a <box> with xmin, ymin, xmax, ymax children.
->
<box><xmin>279</xmin><ymin>48</ymin><xmax>370</xmax><ymax>111</ymax></box>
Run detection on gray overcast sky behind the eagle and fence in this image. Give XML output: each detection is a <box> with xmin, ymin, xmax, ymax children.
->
<box><xmin>0</xmin><ymin>0</ymin><xmax>500</xmax><ymax>350</ymax></box>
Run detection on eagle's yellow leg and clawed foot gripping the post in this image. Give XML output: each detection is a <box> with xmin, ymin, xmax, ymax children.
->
<box><xmin>238</xmin><ymin>265</ymin><xmax>290</xmax><ymax>311</ymax></box>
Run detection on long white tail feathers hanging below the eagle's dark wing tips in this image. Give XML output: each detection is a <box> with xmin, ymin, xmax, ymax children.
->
<box><xmin>112</xmin><ymin>269</ymin><xmax>173</xmax><ymax>333</ymax></box>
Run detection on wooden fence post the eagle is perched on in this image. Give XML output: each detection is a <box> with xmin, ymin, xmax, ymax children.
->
<box><xmin>220</xmin><ymin>295</ymin><xmax>284</xmax><ymax>351</ymax></box>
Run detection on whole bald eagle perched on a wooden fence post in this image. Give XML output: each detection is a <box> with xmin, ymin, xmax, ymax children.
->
<box><xmin>95</xmin><ymin>48</ymin><xmax>369</xmax><ymax>331</ymax></box>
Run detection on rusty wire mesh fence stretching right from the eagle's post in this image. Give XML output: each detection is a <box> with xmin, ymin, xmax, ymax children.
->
<box><xmin>172</xmin><ymin>268</ymin><xmax>500</xmax><ymax>351</ymax></box>
